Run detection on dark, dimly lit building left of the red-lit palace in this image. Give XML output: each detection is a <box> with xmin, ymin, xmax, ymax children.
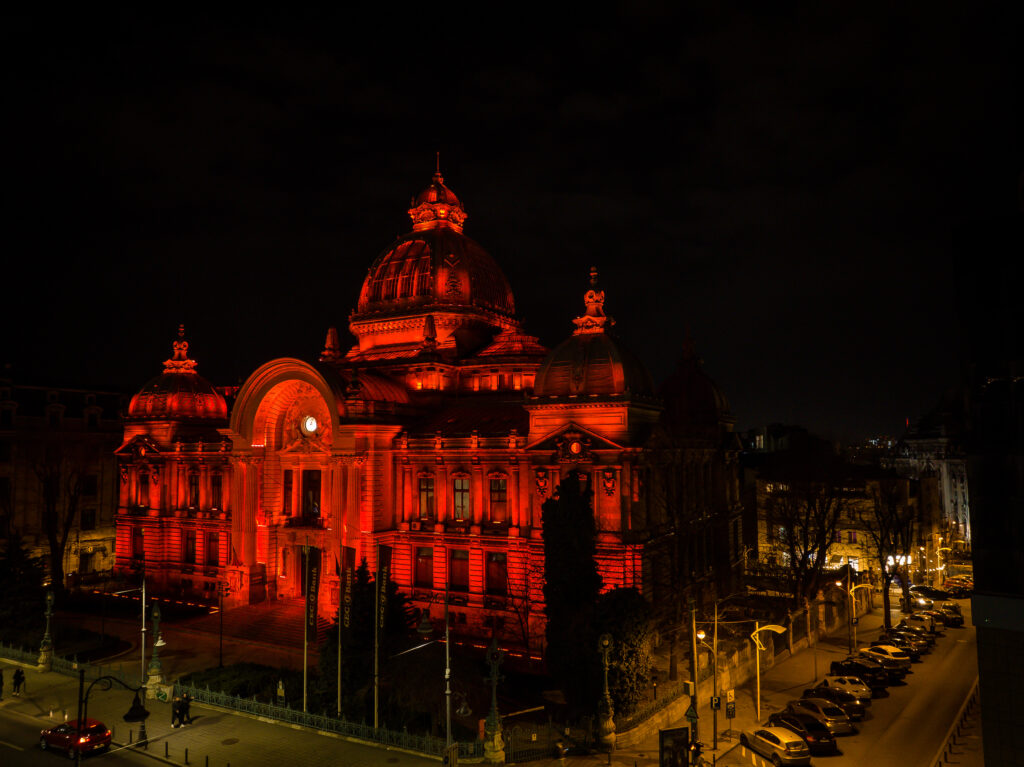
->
<box><xmin>0</xmin><ymin>378</ymin><xmax>125</xmax><ymax>586</ymax></box>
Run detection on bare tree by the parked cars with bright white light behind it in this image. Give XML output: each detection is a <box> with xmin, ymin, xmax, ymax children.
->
<box><xmin>857</xmin><ymin>476</ymin><xmax>916</xmax><ymax>629</ymax></box>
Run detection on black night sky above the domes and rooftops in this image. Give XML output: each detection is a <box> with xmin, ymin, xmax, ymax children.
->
<box><xmin>0</xmin><ymin>3</ymin><xmax>1024</xmax><ymax>440</ymax></box>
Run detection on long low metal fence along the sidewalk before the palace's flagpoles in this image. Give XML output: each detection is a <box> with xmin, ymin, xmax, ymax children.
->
<box><xmin>174</xmin><ymin>684</ymin><xmax>483</xmax><ymax>759</ymax></box>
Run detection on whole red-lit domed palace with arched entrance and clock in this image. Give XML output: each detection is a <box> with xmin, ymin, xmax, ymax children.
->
<box><xmin>116</xmin><ymin>173</ymin><xmax>742</xmax><ymax>648</ymax></box>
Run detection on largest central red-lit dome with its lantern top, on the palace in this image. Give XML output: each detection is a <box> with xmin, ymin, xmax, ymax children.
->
<box><xmin>351</xmin><ymin>173</ymin><xmax>515</xmax><ymax>323</ymax></box>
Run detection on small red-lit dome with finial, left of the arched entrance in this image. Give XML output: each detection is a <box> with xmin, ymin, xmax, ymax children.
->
<box><xmin>128</xmin><ymin>326</ymin><xmax>227</xmax><ymax>420</ymax></box>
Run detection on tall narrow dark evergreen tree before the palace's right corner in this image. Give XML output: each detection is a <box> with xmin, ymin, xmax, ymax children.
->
<box><xmin>541</xmin><ymin>472</ymin><xmax>601</xmax><ymax>715</ymax></box>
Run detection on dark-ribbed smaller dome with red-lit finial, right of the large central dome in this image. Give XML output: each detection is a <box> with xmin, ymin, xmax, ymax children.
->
<box><xmin>534</xmin><ymin>267</ymin><xmax>654</xmax><ymax>396</ymax></box>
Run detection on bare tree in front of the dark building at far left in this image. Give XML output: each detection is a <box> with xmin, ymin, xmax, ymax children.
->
<box><xmin>33</xmin><ymin>441</ymin><xmax>82</xmax><ymax>592</ymax></box>
